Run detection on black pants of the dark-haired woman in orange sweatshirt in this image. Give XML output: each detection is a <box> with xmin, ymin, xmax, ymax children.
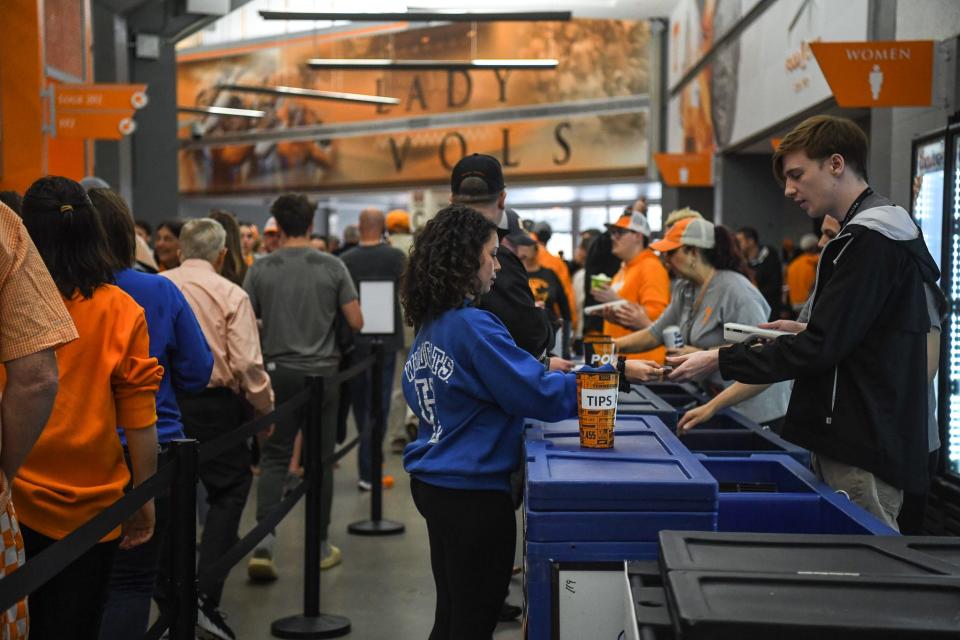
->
<box><xmin>20</xmin><ymin>523</ymin><xmax>119</xmax><ymax>640</ymax></box>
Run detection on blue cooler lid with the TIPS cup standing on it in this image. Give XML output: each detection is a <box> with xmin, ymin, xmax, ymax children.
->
<box><xmin>526</xmin><ymin>424</ymin><xmax>717</xmax><ymax>511</ymax></box>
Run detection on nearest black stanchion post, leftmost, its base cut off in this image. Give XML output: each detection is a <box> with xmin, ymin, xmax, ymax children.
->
<box><xmin>168</xmin><ymin>440</ymin><xmax>199</xmax><ymax>640</ymax></box>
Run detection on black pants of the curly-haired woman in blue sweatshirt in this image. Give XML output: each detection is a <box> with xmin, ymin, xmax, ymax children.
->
<box><xmin>410</xmin><ymin>477</ymin><xmax>517</xmax><ymax>640</ymax></box>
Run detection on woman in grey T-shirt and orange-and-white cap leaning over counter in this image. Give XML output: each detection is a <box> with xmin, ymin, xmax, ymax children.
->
<box><xmin>616</xmin><ymin>218</ymin><xmax>790</xmax><ymax>426</ymax></box>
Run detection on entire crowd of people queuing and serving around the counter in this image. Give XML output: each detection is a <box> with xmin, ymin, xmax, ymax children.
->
<box><xmin>0</xmin><ymin>112</ymin><xmax>945</xmax><ymax>640</ymax></box>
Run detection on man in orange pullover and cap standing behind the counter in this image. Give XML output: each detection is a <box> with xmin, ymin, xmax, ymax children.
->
<box><xmin>593</xmin><ymin>211</ymin><xmax>670</xmax><ymax>364</ymax></box>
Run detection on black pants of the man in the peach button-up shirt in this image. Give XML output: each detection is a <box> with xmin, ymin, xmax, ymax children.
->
<box><xmin>177</xmin><ymin>387</ymin><xmax>253</xmax><ymax>605</ymax></box>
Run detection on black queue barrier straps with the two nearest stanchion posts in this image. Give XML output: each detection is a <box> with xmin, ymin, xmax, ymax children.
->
<box><xmin>0</xmin><ymin>356</ymin><xmax>376</xmax><ymax>640</ymax></box>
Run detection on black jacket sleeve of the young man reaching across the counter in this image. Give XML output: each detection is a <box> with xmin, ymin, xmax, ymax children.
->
<box><xmin>720</xmin><ymin>231</ymin><xmax>911</xmax><ymax>384</ymax></box>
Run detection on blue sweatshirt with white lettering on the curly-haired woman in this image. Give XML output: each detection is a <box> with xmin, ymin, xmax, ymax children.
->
<box><xmin>403</xmin><ymin>307</ymin><xmax>577</xmax><ymax>491</ymax></box>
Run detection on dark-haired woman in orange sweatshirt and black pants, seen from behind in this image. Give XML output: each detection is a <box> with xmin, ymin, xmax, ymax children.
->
<box><xmin>13</xmin><ymin>176</ymin><xmax>163</xmax><ymax>640</ymax></box>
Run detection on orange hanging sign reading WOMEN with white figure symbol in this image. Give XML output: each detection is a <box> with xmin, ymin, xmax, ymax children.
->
<box><xmin>810</xmin><ymin>40</ymin><xmax>933</xmax><ymax>107</ymax></box>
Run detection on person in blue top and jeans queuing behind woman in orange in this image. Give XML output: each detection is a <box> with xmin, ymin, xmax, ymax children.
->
<box><xmin>88</xmin><ymin>189</ymin><xmax>213</xmax><ymax>640</ymax></box>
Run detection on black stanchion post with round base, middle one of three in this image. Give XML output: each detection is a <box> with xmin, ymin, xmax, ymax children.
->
<box><xmin>270</xmin><ymin>376</ymin><xmax>350</xmax><ymax>638</ymax></box>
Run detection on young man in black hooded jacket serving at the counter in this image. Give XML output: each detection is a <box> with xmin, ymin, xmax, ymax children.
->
<box><xmin>668</xmin><ymin>116</ymin><xmax>943</xmax><ymax>528</ymax></box>
